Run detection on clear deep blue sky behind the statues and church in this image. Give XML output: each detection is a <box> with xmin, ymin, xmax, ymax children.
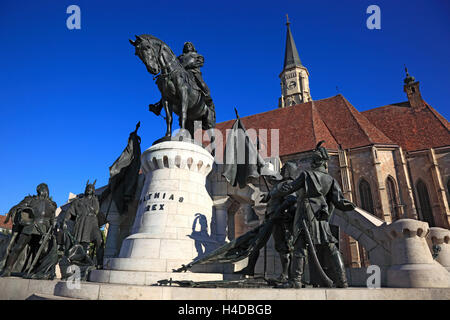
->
<box><xmin>0</xmin><ymin>0</ymin><xmax>450</xmax><ymax>214</ymax></box>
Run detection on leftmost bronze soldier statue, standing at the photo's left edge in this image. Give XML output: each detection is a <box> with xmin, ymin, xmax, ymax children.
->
<box><xmin>1</xmin><ymin>183</ymin><xmax>56</xmax><ymax>277</ymax></box>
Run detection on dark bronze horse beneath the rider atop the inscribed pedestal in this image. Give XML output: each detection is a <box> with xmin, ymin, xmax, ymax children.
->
<box><xmin>130</xmin><ymin>34</ymin><xmax>216</xmax><ymax>137</ymax></box>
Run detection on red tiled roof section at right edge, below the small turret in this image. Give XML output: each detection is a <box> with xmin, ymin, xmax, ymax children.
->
<box><xmin>362</xmin><ymin>101</ymin><xmax>450</xmax><ymax>151</ymax></box>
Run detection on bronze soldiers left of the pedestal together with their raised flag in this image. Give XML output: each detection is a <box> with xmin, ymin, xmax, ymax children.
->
<box><xmin>0</xmin><ymin>122</ymin><xmax>141</xmax><ymax>280</ymax></box>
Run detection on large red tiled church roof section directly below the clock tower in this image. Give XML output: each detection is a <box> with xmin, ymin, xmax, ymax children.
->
<box><xmin>216</xmin><ymin>95</ymin><xmax>395</xmax><ymax>156</ymax></box>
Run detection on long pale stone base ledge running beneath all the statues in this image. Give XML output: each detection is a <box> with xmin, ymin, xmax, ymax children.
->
<box><xmin>0</xmin><ymin>277</ymin><xmax>450</xmax><ymax>301</ymax></box>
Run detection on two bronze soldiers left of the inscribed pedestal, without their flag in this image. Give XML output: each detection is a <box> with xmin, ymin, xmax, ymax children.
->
<box><xmin>0</xmin><ymin>181</ymin><xmax>105</xmax><ymax>280</ymax></box>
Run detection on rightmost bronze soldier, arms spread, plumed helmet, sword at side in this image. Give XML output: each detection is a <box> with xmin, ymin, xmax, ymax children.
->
<box><xmin>270</xmin><ymin>141</ymin><xmax>355</xmax><ymax>288</ymax></box>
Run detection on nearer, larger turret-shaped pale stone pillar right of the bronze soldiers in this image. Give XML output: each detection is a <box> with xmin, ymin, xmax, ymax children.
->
<box><xmin>385</xmin><ymin>219</ymin><xmax>449</xmax><ymax>288</ymax></box>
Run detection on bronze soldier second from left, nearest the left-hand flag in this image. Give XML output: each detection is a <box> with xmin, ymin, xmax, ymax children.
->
<box><xmin>63</xmin><ymin>181</ymin><xmax>104</xmax><ymax>269</ymax></box>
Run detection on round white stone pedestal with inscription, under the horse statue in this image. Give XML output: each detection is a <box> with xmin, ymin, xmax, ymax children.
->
<box><xmin>90</xmin><ymin>141</ymin><xmax>227</xmax><ymax>284</ymax></box>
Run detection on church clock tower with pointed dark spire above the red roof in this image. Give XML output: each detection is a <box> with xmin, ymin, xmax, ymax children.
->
<box><xmin>278</xmin><ymin>15</ymin><xmax>312</xmax><ymax>108</ymax></box>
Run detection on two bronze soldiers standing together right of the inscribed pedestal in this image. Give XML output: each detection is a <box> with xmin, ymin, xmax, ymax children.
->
<box><xmin>236</xmin><ymin>141</ymin><xmax>355</xmax><ymax>288</ymax></box>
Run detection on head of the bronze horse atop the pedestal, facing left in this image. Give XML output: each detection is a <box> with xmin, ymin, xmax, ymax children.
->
<box><xmin>130</xmin><ymin>34</ymin><xmax>162</xmax><ymax>75</ymax></box>
